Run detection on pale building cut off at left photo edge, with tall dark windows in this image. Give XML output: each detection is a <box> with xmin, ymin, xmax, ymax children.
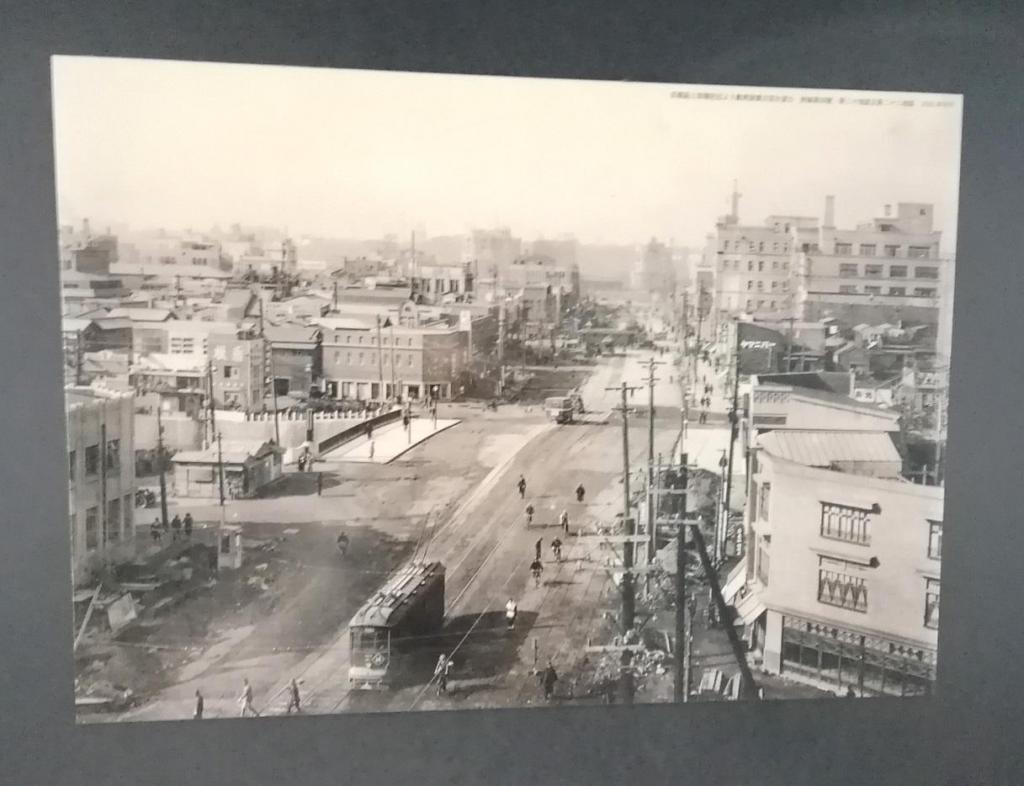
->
<box><xmin>66</xmin><ymin>387</ymin><xmax>135</xmax><ymax>586</ymax></box>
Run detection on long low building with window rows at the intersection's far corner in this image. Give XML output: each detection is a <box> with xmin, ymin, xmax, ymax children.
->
<box><xmin>317</xmin><ymin>318</ymin><xmax>469</xmax><ymax>401</ymax></box>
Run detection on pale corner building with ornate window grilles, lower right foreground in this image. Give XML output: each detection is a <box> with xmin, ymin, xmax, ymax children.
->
<box><xmin>727</xmin><ymin>430</ymin><xmax>943</xmax><ymax>696</ymax></box>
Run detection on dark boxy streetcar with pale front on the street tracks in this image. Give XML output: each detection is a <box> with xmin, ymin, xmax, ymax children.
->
<box><xmin>348</xmin><ymin>562</ymin><xmax>444</xmax><ymax>690</ymax></box>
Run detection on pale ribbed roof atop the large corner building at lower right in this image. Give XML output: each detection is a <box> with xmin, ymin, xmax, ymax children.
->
<box><xmin>760</xmin><ymin>429</ymin><xmax>902</xmax><ymax>467</ymax></box>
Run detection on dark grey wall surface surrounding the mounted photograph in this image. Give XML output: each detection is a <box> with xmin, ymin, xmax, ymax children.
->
<box><xmin>0</xmin><ymin>0</ymin><xmax>1024</xmax><ymax>786</ymax></box>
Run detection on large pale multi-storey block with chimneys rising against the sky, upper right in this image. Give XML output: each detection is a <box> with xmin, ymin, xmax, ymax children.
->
<box><xmin>710</xmin><ymin>193</ymin><xmax>952</xmax><ymax>344</ymax></box>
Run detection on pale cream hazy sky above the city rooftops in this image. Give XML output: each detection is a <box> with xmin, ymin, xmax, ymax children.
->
<box><xmin>46</xmin><ymin>57</ymin><xmax>962</xmax><ymax>248</ymax></box>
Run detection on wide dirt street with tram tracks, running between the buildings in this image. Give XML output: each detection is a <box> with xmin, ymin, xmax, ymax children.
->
<box><xmin>108</xmin><ymin>357</ymin><xmax>678</xmax><ymax>719</ymax></box>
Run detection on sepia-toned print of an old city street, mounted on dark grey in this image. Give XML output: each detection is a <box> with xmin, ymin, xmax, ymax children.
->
<box><xmin>52</xmin><ymin>56</ymin><xmax>963</xmax><ymax>723</ymax></box>
